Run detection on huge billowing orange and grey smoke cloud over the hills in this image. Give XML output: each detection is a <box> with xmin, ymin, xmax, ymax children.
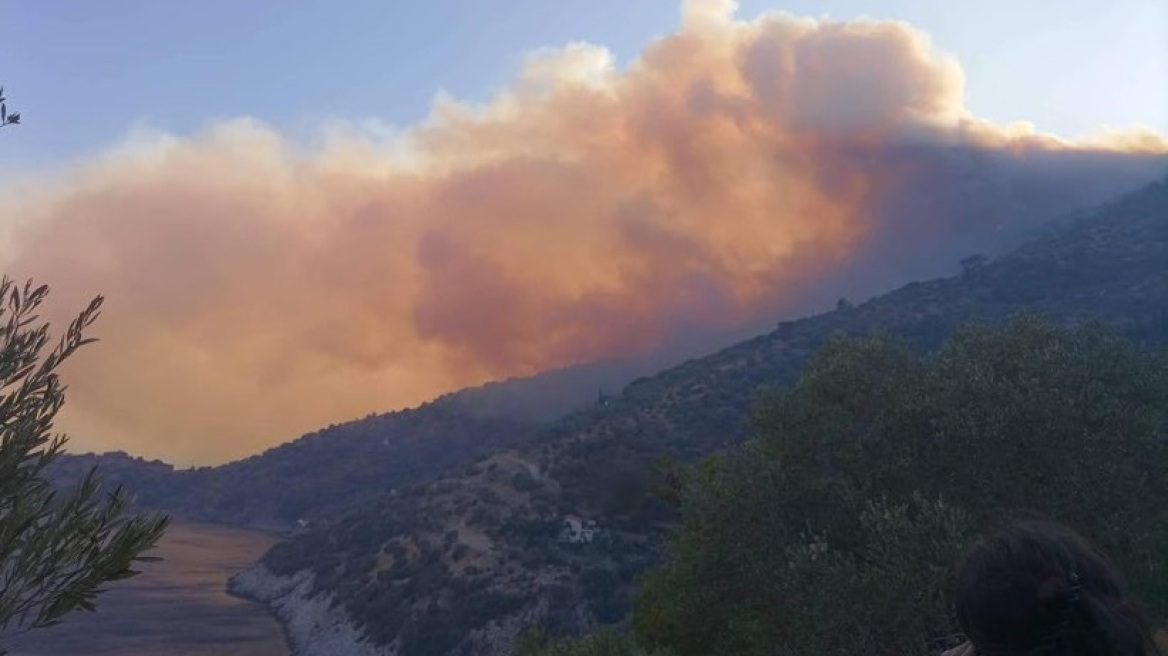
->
<box><xmin>0</xmin><ymin>2</ymin><xmax>1168</xmax><ymax>462</ymax></box>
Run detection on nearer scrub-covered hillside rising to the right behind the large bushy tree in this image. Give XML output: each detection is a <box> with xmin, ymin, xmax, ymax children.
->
<box><xmin>265</xmin><ymin>180</ymin><xmax>1168</xmax><ymax>656</ymax></box>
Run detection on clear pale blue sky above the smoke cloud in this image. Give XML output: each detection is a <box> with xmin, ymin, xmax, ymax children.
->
<box><xmin>0</xmin><ymin>0</ymin><xmax>1168</xmax><ymax>167</ymax></box>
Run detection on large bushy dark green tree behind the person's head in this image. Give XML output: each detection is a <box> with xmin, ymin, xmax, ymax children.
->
<box><xmin>634</xmin><ymin>315</ymin><xmax>1168</xmax><ymax>656</ymax></box>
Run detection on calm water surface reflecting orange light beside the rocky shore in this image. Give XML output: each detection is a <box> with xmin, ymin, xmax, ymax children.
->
<box><xmin>5</xmin><ymin>523</ymin><xmax>288</xmax><ymax>656</ymax></box>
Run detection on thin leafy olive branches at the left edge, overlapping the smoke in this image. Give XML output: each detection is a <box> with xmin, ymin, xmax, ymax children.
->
<box><xmin>0</xmin><ymin>278</ymin><xmax>167</xmax><ymax>654</ymax></box>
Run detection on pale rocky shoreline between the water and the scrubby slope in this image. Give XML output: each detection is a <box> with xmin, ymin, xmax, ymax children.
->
<box><xmin>228</xmin><ymin>565</ymin><xmax>397</xmax><ymax>656</ymax></box>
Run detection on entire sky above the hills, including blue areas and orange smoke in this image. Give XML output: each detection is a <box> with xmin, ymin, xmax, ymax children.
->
<box><xmin>0</xmin><ymin>0</ymin><xmax>1168</xmax><ymax>463</ymax></box>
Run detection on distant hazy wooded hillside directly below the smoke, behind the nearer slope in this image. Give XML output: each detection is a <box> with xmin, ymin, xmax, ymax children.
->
<box><xmin>51</xmin><ymin>363</ymin><xmax>647</xmax><ymax>529</ymax></box>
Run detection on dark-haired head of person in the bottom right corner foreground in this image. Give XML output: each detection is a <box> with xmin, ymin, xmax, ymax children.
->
<box><xmin>957</xmin><ymin>519</ymin><xmax>1159</xmax><ymax>656</ymax></box>
